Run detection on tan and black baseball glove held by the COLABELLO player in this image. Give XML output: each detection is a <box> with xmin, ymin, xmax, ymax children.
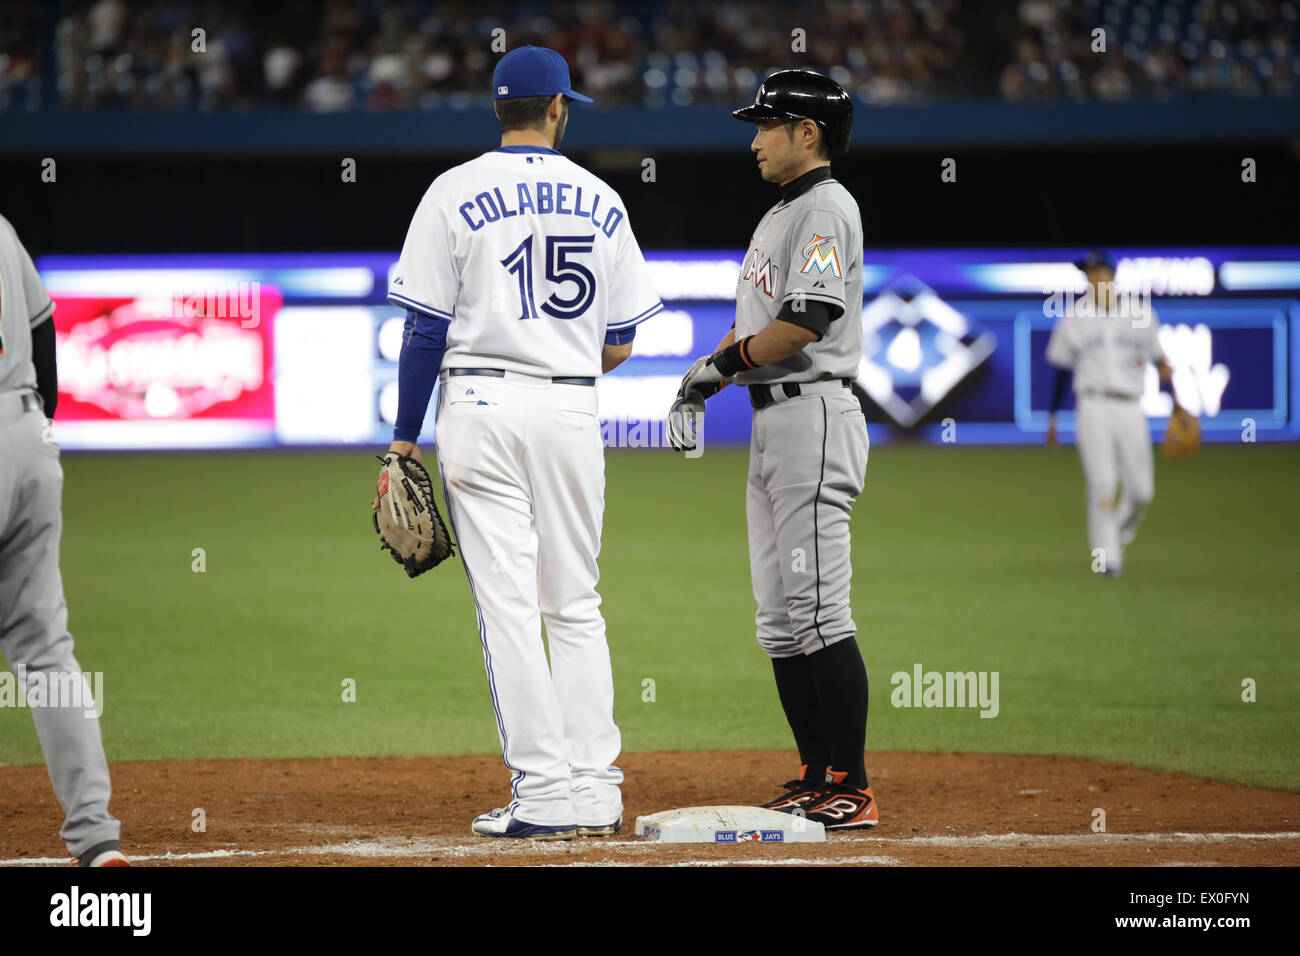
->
<box><xmin>371</xmin><ymin>451</ymin><xmax>455</xmax><ymax>578</ymax></box>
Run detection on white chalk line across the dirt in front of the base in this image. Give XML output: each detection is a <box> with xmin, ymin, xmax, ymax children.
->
<box><xmin>0</xmin><ymin>831</ymin><xmax>1300</xmax><ymax>866</ymax></box>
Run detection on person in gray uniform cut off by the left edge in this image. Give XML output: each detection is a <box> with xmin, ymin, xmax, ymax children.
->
<box><xmin>0</xmin><ymin>216</ymin><xmax>127</xmax><ymax>866</ymax></box>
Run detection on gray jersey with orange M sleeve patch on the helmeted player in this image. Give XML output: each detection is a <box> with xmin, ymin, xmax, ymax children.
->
<box><xmin>736</xmin><ymin>179</ymin><xmax>862</xmax><ymax>385</ymax></box>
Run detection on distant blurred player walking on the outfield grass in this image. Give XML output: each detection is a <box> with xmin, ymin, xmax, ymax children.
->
<box><xmin>1047</xmin><ymin>250</ymin><xmax>1170</xmax><ymax>578</ymax></box>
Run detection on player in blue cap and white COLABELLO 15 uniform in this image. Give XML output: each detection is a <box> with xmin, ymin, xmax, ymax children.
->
<box><xmin>389</xmin><ymin>47</ymin><xmax>663</xmax><ymax>840</ymax></box>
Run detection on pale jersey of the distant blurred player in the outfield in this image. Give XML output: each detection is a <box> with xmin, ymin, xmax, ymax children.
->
<box><xmin>1047</xmin><ymin>303</ymin><xmax>1164</xmax><ymax>398</ymax></box>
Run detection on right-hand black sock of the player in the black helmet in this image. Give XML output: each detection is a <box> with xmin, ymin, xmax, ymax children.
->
<box><xmin>805</xmin><ymin>637</ymin><xmax>867</xmax><ymax>790</ymax></box>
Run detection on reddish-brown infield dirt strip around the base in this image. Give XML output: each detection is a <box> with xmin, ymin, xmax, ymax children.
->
<box><xmin>0</xmin><ymin>750</ymin><xmax>1300</xmax><ymax>866</ymax></box>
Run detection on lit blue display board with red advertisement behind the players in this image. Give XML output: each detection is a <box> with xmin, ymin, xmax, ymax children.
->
<box><xmin>38</xmin><ymin>247</ymin><xmax>1300</xmax><ymax>449</ymax></box>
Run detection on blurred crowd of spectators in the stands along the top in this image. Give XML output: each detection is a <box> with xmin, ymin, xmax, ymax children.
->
<box><xmin>0</xmin><ymin>0</ymin><xmax>1300</xmax><ymax>112</ymax></box>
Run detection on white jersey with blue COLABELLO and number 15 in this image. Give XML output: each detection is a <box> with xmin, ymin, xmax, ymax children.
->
<box><xmin>389</xmin><ymin>146</ymin><xmax>663</xmax><ymax>376</ymax></box>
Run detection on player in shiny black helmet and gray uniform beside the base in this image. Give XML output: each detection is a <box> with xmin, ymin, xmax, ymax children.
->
<box><xmin>680</xmin><ymin>70</ymin><xmax>878</xmax><ymax>829</ymax></box>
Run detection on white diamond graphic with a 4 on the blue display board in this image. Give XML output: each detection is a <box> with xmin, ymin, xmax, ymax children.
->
<box><xmin>858</xmin><ymin>276</ymin><xmax>997</xmax><ymax>428</ymax></box>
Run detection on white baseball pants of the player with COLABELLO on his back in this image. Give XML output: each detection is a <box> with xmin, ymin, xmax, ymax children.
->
<box><xmin>436</xmin><ymin>372</ymin><xmax>623</xmax><ymax>826</ymax></box>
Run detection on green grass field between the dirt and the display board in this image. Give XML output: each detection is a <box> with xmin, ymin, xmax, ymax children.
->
<box><xmin>0</xmin><ymin>445</ymin><xmax>1300</xmax><ymax>791</ymax></box>
